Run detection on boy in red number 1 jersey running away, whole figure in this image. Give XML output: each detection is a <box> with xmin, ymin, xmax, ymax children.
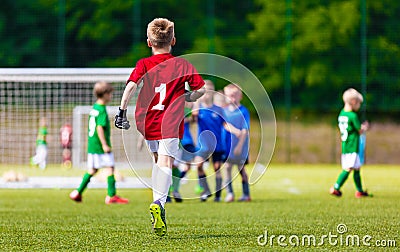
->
<box><xmin>115</xmin><ymin>18</ymin><xmax>205</xmax><ymax>236</ymax></box>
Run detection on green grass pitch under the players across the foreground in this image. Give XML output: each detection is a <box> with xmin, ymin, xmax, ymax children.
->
<box><xmin>0</xmin><ymin>165</ymin><xmax>400</xmax><ymax>251</ymax></box>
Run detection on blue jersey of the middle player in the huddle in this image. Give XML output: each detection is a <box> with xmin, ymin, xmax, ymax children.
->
<box><xmin>197</xmin><ymin>105</ymin><xmax>225</xmax><ymax>154</ymax></box>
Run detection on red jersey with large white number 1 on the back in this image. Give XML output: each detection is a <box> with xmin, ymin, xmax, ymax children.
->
<box><xmin>128</xmin><ymin>53</ymin><xmax>204</xmax><ymax>140</ymax></box>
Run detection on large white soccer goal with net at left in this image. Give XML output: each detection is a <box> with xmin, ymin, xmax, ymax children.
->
<box><xmin>0</xmin><ymin>68</ymin><xmax>151</xmax><ymax>169</ymax></box>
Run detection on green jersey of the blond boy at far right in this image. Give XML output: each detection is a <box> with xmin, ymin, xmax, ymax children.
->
<box><xmin>338</xmin><ymin>109</ymin><xmax>361</xmax><ymax>154</ymax></box>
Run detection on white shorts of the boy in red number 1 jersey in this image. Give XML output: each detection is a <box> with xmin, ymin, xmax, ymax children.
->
<box><xmin>146</xmin><ymin>138</ymin><xmax>179</xmax><ymax>158</ymax></box>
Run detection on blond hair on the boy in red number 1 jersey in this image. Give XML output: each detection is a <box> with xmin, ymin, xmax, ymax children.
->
<box><xmin>147</xmin><ymin>18</ymin><xmax>175</xmax><ymax>48</ymax></box>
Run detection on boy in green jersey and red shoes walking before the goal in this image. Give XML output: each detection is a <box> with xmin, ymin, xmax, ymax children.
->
<box><xmin>69</xmin><ymin>82</ymin><xmax>128</xmax><ymax>204</ymax></box>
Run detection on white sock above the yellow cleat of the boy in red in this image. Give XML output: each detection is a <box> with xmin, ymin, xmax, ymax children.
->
<box><xmin>153</xmin><ymin>167</ymin><xmax>172</xmax><ymax>207</ymax></box>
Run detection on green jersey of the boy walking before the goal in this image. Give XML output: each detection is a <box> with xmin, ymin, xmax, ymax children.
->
<box><xmin>88</xmin><ymin>103</ymin><xmax>111</xmax><ymax>154</ymax></box>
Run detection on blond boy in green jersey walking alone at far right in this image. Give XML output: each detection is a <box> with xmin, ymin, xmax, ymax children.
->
<box><xmin>330</xmin><ymin>88</ymin><xmax>369</xmax><ymax>198</ymax></box>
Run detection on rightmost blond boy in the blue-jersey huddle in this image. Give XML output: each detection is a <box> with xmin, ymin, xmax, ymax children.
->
<box><xmin>224</xmin><ymin>84</ymin><xmax>251</xmax><ymax>202</ymax></box>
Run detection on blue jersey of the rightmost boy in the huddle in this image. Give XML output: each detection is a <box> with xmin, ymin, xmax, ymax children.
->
<box><xmin>224</xmin><ymin>105</ymin><xmax>250</xmax><ymax>163</ymax></box>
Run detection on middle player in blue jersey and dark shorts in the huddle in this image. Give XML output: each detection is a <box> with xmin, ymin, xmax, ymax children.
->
<box><xmin>194</xmin><ymin>80</ymin><xmax>225</xmax><ymax>202</ymax></box>
